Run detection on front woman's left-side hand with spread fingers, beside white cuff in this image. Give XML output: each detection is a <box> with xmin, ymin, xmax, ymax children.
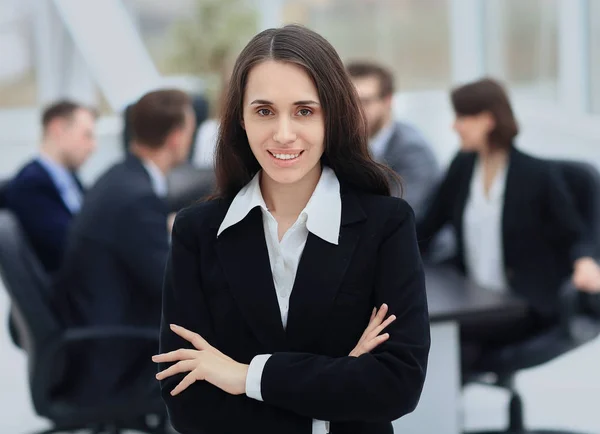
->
<box><xmin>152</xmin><ymin>324</ymin><xmax>248</xmax><ymax>396</ymax></box>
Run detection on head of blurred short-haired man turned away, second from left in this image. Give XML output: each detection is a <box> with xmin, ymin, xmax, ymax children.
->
<box><xmin>129</xmin><ymin>89</ymin><xmax>196</xmax><ymax>173</ymax></box>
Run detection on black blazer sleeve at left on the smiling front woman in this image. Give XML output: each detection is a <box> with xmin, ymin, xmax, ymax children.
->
<box><xmin>159</xmin><ymin>210</ymin><xmax>312</xmax><ymax>434</ymax></box>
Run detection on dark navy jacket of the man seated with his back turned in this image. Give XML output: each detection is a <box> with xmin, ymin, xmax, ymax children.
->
<box><xmin>55</xmin><ymin>156</ymin><xmax>169</xmax><ymax>399</ymax></box>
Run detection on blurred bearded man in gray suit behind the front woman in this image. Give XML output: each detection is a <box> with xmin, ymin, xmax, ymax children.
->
<box><xmin>347</xmin><ymin>62</ymin><xmax>440</xmax><ymax>219</ymax></box>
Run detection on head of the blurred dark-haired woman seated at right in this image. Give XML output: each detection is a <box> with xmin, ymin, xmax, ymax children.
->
<box><xmin>451</xmin><ymin>78</ymin><xmax>519</xmax><ymax>152</ymax></box>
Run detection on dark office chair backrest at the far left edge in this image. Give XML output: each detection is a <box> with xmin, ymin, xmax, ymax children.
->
<box><xmin>0</xmin><ymin>209</ymin><xmax>62</xmax><ymax>361</ymax></box>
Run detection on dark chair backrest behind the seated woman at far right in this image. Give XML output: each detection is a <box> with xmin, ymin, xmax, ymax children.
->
<box><xmin>556</xmin><ymin>160</ymin><xmax>600</xmax><ymax>249</ymax></box>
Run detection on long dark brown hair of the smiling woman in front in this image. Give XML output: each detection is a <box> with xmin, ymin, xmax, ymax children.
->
<box><xmin>215</xmin><ymin>25</ymin><xmax>397</xmax><ymax>198</ymax></box>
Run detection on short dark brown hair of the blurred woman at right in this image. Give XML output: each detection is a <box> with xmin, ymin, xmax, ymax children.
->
<box><xmin>451</xmin><ymin>78</ymin><xmax>519</xmax><ymax>149</ymax></box>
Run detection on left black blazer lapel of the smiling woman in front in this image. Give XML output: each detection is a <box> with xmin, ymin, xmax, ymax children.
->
<box><xmin>216</xmin><ymin>207</ymin><xmax>286</xmax><ymax>352</ymax></box>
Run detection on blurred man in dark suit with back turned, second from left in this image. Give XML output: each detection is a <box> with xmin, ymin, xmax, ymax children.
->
<box><xmin>56</xmin><ymin>90</ymin><xmax>196</xmax><ymax>403</ymax></box>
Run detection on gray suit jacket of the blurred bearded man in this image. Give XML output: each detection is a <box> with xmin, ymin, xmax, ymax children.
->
<box><xmin>379</xmin><ymin>121</ymin><xmax>441</xmax><ymax>220</ymax></box>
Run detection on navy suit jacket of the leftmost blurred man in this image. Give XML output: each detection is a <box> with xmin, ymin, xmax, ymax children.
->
<box><xmin>5</xmin><ymin>160</ymin><xmax>83</xmax><ymax>273</ymax></box>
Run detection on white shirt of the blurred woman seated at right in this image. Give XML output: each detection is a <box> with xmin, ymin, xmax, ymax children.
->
<box><xmin>463</xmin><ymin>162</ymin><xmax>508</xmax><ymax>291</ymax></box>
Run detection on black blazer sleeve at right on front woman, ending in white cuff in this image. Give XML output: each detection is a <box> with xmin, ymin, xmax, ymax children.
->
<box><xmin>261</xmin><ymin>200</ymin><xmax>430</xmax><ymax>422</ymax></box>
